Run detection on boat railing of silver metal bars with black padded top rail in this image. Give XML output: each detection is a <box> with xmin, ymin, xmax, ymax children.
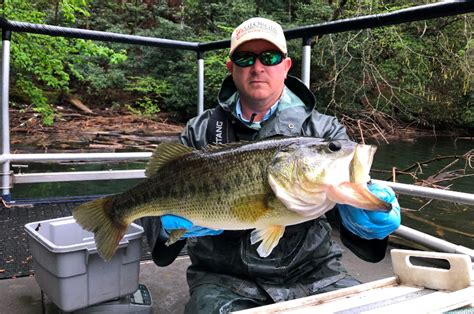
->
<box><xmin>0</xmin><ymin>0</ymin><xmax>474</xmax><ymax>259</ymax></box>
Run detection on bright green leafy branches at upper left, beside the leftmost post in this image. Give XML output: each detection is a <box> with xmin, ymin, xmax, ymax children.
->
<box><xmin>1</xmin><ymin>0</ymin><xmax>126</xmax><ymax>124</ymax></box>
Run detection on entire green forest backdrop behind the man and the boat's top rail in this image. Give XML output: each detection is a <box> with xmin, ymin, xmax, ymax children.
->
<box><xmin>2</xmin><ymin>0</ymin><xmax>474</xmax><ymax>127</ymax></box>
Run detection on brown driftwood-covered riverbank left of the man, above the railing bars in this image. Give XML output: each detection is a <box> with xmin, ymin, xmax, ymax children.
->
<box><xmin>10</xmin><ymin>108</ymin><xmax>184</xmax><ymax>153</ymax></box>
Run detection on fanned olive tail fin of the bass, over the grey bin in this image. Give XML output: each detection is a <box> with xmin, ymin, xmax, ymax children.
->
<box><xmin>72</xmin><ymin>197</ymin><xmax>128</xmax><ymax>261</ymax></box>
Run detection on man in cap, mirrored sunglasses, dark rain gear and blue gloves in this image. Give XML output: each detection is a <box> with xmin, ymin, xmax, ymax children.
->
<box><xmin>143</xmin><ymin>18</ymin><xmax>400</xmax><ymax>314</ymax></box>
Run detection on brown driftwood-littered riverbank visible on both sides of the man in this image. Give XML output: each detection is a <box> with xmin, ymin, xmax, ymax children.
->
<box><xmin>10</xmin><ymin>107</ymin><xmax>472</xmax><ymax>153</ymax></box>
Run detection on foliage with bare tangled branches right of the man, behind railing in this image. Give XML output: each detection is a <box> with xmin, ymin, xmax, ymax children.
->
<box><xmin>290</xmin><ymin>1</ymin><xmax>474</xmax><ymax>126</ymax></box>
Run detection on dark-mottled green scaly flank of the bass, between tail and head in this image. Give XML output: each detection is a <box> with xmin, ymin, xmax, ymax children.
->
<box><xmin>112</xmin><ymin>141</ymin><xmax>278</xmax><ymax>229</ymax></box>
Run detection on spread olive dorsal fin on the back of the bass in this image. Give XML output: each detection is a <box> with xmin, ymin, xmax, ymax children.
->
<box><xmin>145</xmin><ymin>143</ymin><xmax>193</xmax><ymax>177</ymax></box>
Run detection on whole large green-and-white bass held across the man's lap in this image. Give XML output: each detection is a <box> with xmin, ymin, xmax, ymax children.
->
<box><xmin>73</xmin><ymin>137</ymin><xmax>390</xmax><ymax>260</ymax></box>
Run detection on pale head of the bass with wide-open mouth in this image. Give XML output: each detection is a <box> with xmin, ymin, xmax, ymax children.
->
<box><xmin>268</xmin><ymin>140</ymin><xmax>390</xmax><ymax>217</ymax></box>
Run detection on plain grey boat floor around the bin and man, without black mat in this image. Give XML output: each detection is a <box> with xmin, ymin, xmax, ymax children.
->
<box><xmin>0</xmin><ymin>237</ymin><xmax>393</xmax><ymax>314</ymax></box>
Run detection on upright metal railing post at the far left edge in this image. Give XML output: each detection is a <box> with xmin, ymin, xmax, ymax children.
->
<box><xmin>0</xmin><ymin>29</ymin><xmax>11</xmax><ymax>202</ymax></box>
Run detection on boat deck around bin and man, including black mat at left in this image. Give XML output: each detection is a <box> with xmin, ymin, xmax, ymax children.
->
<box><xmin>0</xmin><ymin>199</ymin><xmax>393</xmax><ymax>314</ymax></box>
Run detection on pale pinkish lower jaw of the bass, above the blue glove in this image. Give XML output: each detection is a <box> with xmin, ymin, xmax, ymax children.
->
<box><xmin>327</xmin><ymin>182</ymin><xmax>392</xmax><ymax>211</ymax></box>
